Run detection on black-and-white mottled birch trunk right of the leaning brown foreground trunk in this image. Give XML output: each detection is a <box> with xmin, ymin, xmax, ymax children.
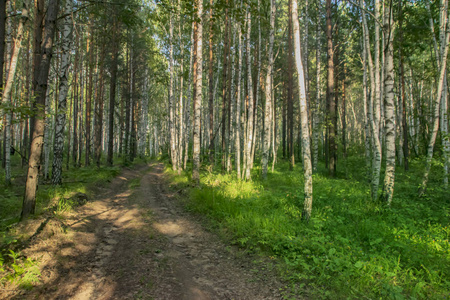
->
<box><xmin>52</xmin><ymin>0</ymin><xmax>72</xmax><ymax>185</ymax></box>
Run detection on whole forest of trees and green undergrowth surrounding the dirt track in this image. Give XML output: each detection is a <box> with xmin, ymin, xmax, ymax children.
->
<box><xmin>0</xmin><ymin>0</ymin><xmax>450</xmax><ymax>300</ymax></box>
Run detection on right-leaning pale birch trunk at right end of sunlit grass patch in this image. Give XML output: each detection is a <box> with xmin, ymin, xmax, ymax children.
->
<box><xmin>261</xmin><ymin>0</ymin><xmax>276</xmax><ymax>179</ymax></box>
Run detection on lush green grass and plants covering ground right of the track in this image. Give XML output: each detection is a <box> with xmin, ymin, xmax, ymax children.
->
<box><xmin>167</xmin><ymin>157</ymin><xmax>450</xmax><ymax>299</ymax></box>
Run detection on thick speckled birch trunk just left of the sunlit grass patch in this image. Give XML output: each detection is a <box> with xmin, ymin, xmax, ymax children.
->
<box><xmin>192</xmin><ymin>0</ymin><xmax>203</xmax><ymax>185</ymax></box>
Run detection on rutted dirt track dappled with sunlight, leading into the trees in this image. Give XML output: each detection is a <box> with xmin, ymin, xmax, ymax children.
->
<box><xmin>0</xmin><ymin>162</ymin><xmax>286</xmax><ymax>300</ymax></box>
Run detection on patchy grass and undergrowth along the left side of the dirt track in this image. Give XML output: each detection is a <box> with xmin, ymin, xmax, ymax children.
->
<box><xmin>0</xmin><ymin>157</ymin><xmax>120</xmax><ymax>289</ymax></box>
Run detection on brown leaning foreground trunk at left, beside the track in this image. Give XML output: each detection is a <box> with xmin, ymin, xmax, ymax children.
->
<box><xmin>21</xmin><ymin>0</ymin><xmax>59</xmax><ymax>219</ymax></box>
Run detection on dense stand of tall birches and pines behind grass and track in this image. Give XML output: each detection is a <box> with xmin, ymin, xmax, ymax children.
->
<box><xmin>0</xmin><ymin>0</ymin><xmax>450</xmax><ymax>219</ymax></box>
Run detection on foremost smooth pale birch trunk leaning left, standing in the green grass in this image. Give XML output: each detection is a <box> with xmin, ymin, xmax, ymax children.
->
<box><xmin>292</xmin><ymin>0</ymin><xmax>313</xmax><ymax>221</ymax></box>
